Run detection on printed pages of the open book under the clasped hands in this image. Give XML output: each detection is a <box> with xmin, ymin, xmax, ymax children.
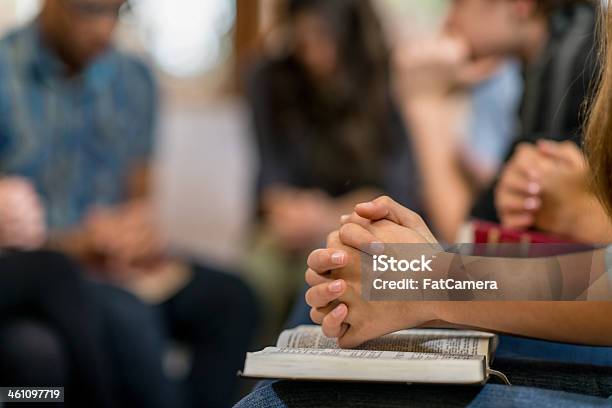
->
<box><xmin>277</xmin><ymin>326</ymin><xmax>493</xmax><ymax>356</ymax></box>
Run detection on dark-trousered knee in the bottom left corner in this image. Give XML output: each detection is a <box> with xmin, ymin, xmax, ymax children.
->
<box><xmin>0</xmin><ymin>320</ymin><xmax>69</xmax><ymax>386</ymax></box>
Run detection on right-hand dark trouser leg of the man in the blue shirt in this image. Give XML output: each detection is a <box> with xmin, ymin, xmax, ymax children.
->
<box><xmin>159</xmin><ymin>266</ymin><xmax>259</xmax><ymax>408</ymax></box>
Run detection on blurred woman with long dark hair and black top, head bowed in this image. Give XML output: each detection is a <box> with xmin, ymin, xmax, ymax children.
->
<box><xmin>243</xmin><ymin>0</ymin><xmax>420</xmax><ymax>338</ymax></box>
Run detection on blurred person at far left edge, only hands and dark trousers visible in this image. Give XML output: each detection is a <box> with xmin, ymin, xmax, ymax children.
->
<box><xmin>0</xmin><ymin>177</ymin><xmax>117</xmax><ymax>408</ymax></box>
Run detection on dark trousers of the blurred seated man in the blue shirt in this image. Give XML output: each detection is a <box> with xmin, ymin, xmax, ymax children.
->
<box><xmin>91</xmin><ymin>266</ymin><xmax>258</xmax><ymax>408</ymax></box>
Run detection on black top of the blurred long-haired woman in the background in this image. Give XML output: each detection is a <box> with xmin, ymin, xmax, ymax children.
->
<box><xmin>248</xmin><ymin>57</ymin><xmax>422</xmax><ymax>211</ymax></box>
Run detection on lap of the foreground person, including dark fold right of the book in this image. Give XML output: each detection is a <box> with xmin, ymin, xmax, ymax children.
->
<box><xmin>237</xmin><ymin>360</ymin><xmax>612</xmax><ymax>408</ymax></box>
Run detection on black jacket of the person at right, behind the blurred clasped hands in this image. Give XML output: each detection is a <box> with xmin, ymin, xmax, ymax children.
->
<box><xmin>471</xmin><ymin>4</ymin><xmax>598</xmax><ymax>222</ymax></box>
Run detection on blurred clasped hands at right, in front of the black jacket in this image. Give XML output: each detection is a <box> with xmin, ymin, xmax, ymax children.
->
<box><xmin>495</xmin><ymin>140</ymin><xmax>612</xmax><ymax>243</ymax></box>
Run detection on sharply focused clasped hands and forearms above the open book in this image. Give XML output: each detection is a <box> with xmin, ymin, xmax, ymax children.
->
<box><xmin>306</xmin><ymin>198</ymin><xmax>612</xmax><ymax>347</ymax></box>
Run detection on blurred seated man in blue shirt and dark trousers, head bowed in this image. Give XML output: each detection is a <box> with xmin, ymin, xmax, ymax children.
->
<box><xmin>0</xmin><ymin>0</ymin><xmax>257</xmax><ymax>407</ymax></box>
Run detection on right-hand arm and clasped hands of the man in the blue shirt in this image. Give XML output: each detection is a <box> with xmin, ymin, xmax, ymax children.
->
<box><xmin>49</xmin><ymin>60</ymin><xmax>165</xmax><ymax>275</ymax></box>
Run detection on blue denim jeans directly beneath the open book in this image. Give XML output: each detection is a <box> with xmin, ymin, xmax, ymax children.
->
<box><xmin>234</xmin><ymin>381</ymin><xmax>612</xmax><ymax>408</ymax></box>
